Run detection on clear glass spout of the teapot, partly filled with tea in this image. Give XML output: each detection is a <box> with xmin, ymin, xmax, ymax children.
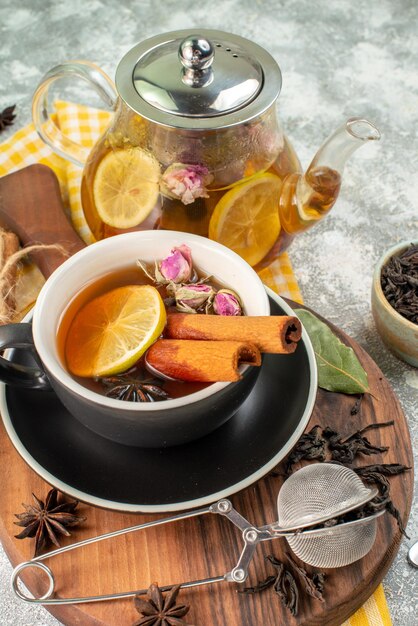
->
<box><xmin>279</xmin><ymin>117</ymin><xmax>380</xmax><ymax>235</ymax></box>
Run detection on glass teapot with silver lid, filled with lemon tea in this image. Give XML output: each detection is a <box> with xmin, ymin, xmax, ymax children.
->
<box><xmin>33</xmin><ymin>29</ymin><xmax>380</xmax><ymax>268</ymax></box>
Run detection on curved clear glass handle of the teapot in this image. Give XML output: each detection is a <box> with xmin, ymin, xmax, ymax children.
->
<box><xmin>32</xmin><ymin>61</ymin><xmax>118</xmax><ymax>167</ymax></box>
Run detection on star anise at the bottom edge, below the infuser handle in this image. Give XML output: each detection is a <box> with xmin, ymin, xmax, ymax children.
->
<box><xmin>132</xmin><ymin>583</ymin><xmax>190</xmax><ymax>626</ymax></box>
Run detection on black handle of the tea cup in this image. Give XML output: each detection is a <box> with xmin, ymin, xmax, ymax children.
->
<box><xmin>0</xmin><ymin>323</ymin><xmax>51</xmax><ymax>391</ymax></box>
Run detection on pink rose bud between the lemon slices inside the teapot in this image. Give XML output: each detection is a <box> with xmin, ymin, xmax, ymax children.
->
<box><xmin>161</xmin><ymin>163</ymin><xmax>213</xmax><ymax>204</ymax></box>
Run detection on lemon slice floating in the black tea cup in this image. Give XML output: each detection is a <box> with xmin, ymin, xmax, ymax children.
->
<box><xmin>65</xmin><ymin>285</ymin><xmax>166</xmax><ymax>378</ymax></box>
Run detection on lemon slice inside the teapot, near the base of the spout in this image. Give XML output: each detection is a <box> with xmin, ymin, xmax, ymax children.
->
<box><xmin>209</xmin><ymin>173</ymin><xmax>282</xmax><ymax>265</ymax></box>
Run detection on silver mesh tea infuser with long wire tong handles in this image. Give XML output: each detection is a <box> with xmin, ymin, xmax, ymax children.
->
<box><xmin>11</xmin><ymin>463</ymin><xmax>384</xmax><ymax>605</ymax></box>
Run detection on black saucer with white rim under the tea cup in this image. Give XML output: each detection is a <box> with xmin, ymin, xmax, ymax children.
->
<box><xmin>0</xmin><ymin>291</ymin><xmax>316</xmax><ymax>512</ymax></box>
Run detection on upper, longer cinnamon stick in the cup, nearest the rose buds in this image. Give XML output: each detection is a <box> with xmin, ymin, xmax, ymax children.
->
<box><xmin>165</xmin><ymin>313</ymin><xmax>302</xmax><ymax>354</ymax></box>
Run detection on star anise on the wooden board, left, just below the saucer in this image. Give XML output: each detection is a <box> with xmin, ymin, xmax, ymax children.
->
<box><xmin>14</xmin><ymin>489</ymin><xmax>86</xmax><ymax>556</ymax></box>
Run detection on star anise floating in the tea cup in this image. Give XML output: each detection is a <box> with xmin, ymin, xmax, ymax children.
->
<box><xmin>99</xmin><ymin>369</ymin><xmax>170</xmax><ymax>402</ymax></box>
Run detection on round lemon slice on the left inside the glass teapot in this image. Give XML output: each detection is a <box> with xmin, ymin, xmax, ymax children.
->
<box><xmin>93</xmin><ymin>148</ymin><xmax>160</xmax><ymax>228</ymax></box>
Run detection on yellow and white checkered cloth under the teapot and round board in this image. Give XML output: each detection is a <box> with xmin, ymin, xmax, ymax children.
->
<box><xmin>0</xmin><ymin>102</ymin><xmax>392</xmax><ymax>626</ymax></box>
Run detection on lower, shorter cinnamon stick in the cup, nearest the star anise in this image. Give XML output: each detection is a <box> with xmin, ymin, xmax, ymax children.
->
<box><xmin>146</xmin><ymin>336</ymin><xmax>261</xmax><ymax>383</ymax></box>
